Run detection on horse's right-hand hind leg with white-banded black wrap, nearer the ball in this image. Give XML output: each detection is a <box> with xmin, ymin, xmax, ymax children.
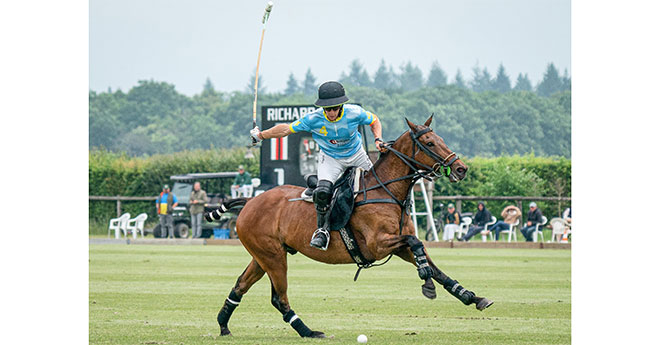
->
<box><xmin>264</xmin><ymin>253</ymin><xmax>325</xmax><ymax>338</ymax></box>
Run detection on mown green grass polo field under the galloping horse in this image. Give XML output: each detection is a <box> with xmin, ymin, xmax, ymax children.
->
<box><xmin>89</xmin><ymin>245</ymin><xmax>571</xmax><ymax>344</ymax></box>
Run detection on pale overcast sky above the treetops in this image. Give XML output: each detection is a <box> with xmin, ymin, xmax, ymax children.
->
<box><xmin>89</xmin><ymin>0</ymin><xmax>571</xmax><ymax>95</ymax></box>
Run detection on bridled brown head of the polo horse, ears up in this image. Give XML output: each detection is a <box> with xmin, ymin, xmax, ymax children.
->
<box><xmin>406</xmin><ymin>115</ymin><xmax>468</xmax><ymax>182</ymax></box>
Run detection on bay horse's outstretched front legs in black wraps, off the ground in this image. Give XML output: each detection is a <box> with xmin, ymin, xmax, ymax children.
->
<box><xmin>395</xmin><ymin>235</ymin><xmax>493</xmax><ymax>310</ymax></box>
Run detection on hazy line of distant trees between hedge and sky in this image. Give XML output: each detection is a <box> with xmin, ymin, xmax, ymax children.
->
<box><xmin>89</xmin><ymin>60</ymin><xmax>571</xmax><ymax>157</ymax></box>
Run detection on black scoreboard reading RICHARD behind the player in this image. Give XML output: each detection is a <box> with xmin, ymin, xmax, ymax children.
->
<box><xmin>258</xmin><ymin>105</ymin><xmax>368</xmax><ymax>190</ymax></box>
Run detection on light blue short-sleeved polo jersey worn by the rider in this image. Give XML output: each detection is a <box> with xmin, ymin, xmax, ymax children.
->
<box><xmin>289</xmin><ymin>104</ymin><xmax>376</xmax><ymax>158</ymax></box>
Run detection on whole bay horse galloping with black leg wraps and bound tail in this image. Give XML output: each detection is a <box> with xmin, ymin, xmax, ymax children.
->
<box><xmin>207</xmin><ymin>115</ymin><xmax>493</xmax><ymax>338</ymax></box>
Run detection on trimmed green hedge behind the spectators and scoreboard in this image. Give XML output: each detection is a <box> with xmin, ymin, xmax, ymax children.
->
<box><xmin>89</xmin><ymin>148</ymin><xmax>571</xmax><ymax>222</ymax></box>
